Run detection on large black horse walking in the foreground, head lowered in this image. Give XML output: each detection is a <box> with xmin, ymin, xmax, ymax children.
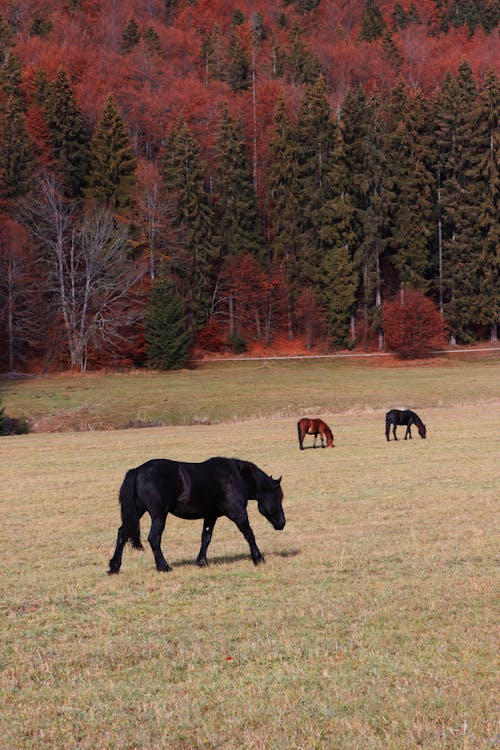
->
<box><xmin>108</xmin><ymin>457</ymin><xmax>285</xmax><ymax>573</ymax></box>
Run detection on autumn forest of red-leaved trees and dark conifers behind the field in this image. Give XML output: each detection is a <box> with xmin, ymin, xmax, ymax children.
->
<box><xmin>0</xmin><ymin>0</ymin><xmax>500</xmax><ymax>372</ymax></box>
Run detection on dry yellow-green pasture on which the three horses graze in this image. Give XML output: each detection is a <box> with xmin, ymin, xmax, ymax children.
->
<box><xmin>0</xmin><ymin>361</ymin><xmax>500</xmax><ymax>750</ymax></box>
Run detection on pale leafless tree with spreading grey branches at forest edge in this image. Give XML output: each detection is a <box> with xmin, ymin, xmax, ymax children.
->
<box><xmin>23</xmin><ymin>175</ymin><xmax>143</xmax><ymax>372</ymax></box>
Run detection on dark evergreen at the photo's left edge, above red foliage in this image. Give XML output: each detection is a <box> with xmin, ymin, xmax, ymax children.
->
<box><xmin>0</xmin><ymin>96</ymin><xmax>35</xmax><ymax>199</ymax></box>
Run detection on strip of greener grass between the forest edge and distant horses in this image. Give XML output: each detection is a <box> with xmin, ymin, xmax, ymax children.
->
<box><xmin>0</xmin><ymin>358</ymin><xmax>499</xmax><ymax>431</ymax></box>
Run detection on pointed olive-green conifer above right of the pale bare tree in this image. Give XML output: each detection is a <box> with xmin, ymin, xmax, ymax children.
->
<box><xmin>85</xmin><ymin>94</ymin><xmax>135</xmax><ymax>212</ymax></box>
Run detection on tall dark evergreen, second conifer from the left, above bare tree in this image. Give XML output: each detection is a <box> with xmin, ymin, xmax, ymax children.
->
<box><xmin>43</xmin><ymin>70</ymin><xmax>89</xmax><ymax>197</ymax></box>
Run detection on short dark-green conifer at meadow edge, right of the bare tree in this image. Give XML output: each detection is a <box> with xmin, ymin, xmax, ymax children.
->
<box><xmin>146</xmin><ymin>276</ymin><xmax>190</xmax><ymax>370</ymax></box>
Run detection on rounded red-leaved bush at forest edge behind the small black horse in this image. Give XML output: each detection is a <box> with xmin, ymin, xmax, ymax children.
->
<box><xmin>382</xmin><ymin>289</ymin><xmax>448</xmax><ymax>358</ymax></box>
